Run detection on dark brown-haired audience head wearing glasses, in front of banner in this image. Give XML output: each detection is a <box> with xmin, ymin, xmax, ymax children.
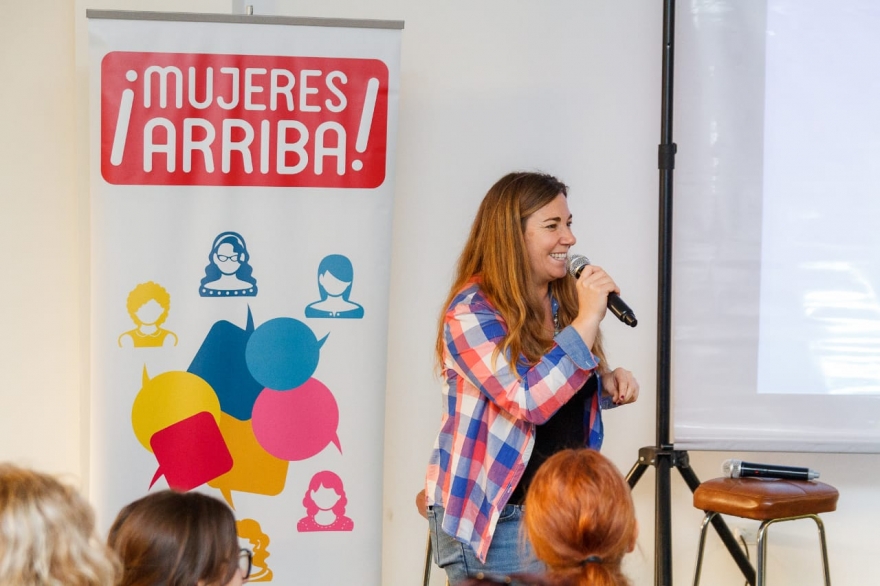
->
<box><xmin>108</xmin><ymin>490</ymin><xmax>250</xmax><ymax>586</ymax></box>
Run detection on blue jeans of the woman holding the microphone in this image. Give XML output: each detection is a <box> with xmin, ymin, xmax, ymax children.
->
<box><xmin>428</xmin><ymin>505</ymin><xmax>545</xmax><ymax>586</ymax></box>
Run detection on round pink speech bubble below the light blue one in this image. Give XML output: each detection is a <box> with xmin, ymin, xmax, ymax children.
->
<box><xmin>251</xmin><ymin>378</ymin><xmax>342</xmax><ymax>461</ymax></box>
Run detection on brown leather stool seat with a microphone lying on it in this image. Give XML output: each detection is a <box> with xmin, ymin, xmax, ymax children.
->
<box><xmin>694</xmin><ymin>478</ymin><xmax>839</xmax><ymax>521</ymax></box>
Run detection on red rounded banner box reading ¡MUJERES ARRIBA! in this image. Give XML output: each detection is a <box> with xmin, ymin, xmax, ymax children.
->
<box><xmin>101</xmin><ymin>52</ymin><xmax>388</xmax><ymax>188</ymax></box>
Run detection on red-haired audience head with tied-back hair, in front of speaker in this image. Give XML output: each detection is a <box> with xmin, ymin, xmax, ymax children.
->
<box><xmin>524</xmin><ymin>449</ymin><xmax>638</xmax><ymax>586</ymax></box>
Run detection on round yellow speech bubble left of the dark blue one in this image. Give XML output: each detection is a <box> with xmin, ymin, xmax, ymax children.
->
<box><xmin>131</xmin><ymin>367</ymin><xmax>220</xmax><ymax>452</ymax></box>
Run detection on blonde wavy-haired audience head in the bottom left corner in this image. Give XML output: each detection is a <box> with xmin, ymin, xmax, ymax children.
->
<box><xmin>0</xmin><ymin>464</ymin><xmax>118</xmax><ymax>586</ymax></box>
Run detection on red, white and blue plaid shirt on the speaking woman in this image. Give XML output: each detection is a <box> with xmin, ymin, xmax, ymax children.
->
<box><xmin>426</xmin><ymin>279</ymin><xmax>601</xmax><ymax>562</ymax></box>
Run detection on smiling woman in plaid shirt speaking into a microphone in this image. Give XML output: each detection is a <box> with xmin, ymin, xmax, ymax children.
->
<box><xmin>425</xmin><ymin>172</ymin><xmax>639</xmax><ymax>585</ymax></box>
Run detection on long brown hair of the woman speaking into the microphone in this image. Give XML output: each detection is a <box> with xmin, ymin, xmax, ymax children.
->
<box><xmin>436</xmin><ymin>172</ymin><xmax>605</xmax><ymax>370</ymax></box>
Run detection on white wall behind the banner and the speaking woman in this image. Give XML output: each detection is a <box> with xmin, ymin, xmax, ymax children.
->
<box><xmin>0</xmin><ymin>0</ymin><xmax>880</xmax><ymax>586</ymax></box>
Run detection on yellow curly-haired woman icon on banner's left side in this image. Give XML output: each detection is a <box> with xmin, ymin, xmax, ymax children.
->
<box><xmin>118</xmin><ymin>281</ymin><xmax>177</xmax><ymax>348</ymax></box>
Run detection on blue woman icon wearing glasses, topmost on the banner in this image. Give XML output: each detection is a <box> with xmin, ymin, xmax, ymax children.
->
<box><xmin>199</xmin><ymin>232</ymin><xmax>257</xmax><ymax>297</ymax></box>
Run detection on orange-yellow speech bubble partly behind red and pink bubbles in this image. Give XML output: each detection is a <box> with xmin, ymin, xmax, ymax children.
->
<box><xmin>208</xmin><ymin>413</ymin><xmax>290</xmax><ymax>508</ymax></box>
